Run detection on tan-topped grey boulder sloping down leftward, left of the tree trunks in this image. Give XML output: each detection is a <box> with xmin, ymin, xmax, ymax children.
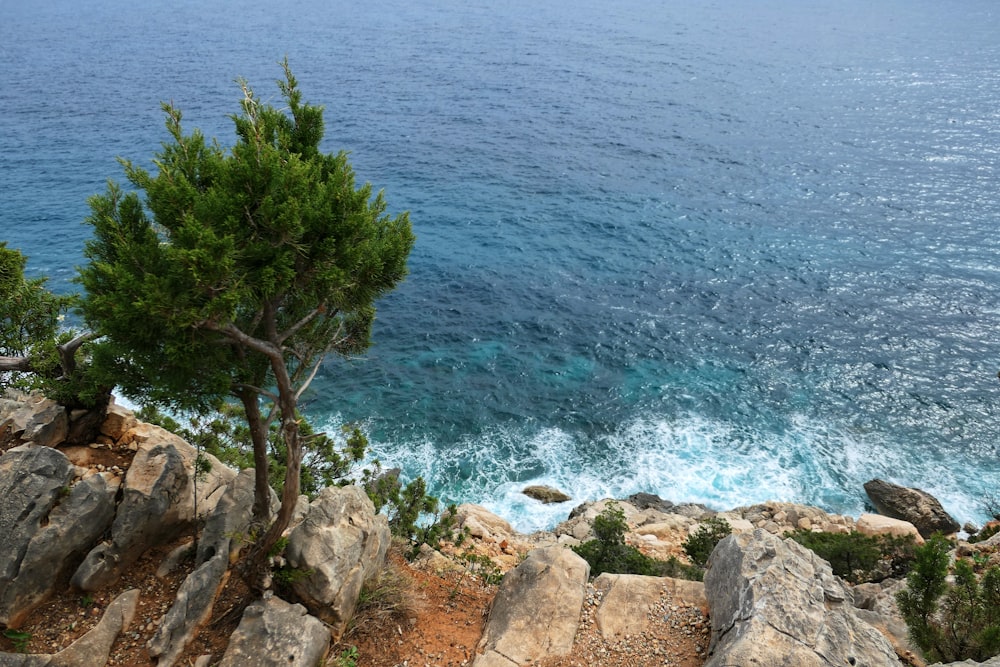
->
<box><xmin>72</xmin><ymin>424</ymin><xmax>236</xmax><ymax>591</ymax></box>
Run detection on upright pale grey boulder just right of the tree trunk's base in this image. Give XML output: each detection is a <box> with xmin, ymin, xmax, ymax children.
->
<box><xmin>285</xmin><ymin>486</ymin><xmax>390</xmax><ymax>639</ymax></box>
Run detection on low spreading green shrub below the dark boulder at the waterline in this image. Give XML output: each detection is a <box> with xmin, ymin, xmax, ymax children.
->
<box><xmin>789</xmin><ymin>529</ymin><xmax>916</xmax><ymax>584</ymax></box>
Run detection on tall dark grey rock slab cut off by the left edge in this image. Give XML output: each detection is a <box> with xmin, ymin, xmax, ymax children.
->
<box><xmin>0</xmin><ymin>445</ymin><xmax>73</xmax><ymax>624</ymax></box>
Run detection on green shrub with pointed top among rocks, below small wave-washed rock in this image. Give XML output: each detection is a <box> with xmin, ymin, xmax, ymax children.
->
<box><xmin>573</xmin><ymin>501</ymin><xmax>702</xmax><ymax>579</ymax></box>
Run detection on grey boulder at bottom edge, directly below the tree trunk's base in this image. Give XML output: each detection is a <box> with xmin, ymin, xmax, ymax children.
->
<box><xmin>219</xmin><ymin>597</ymin><xmax>330</xmax><ymax>667</ymax></box>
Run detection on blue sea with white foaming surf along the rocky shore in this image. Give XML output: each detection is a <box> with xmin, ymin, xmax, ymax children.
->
<box><xmin>0</xmin><ymin>0</ymin><xmax>1000</xmax><ymax>530</ymax></box>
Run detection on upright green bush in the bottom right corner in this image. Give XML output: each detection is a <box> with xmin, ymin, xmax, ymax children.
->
<box><xmin>896</xmin><ymin>535</ymin><xmax>1000</xmax><ymax>662</ymax></box>
